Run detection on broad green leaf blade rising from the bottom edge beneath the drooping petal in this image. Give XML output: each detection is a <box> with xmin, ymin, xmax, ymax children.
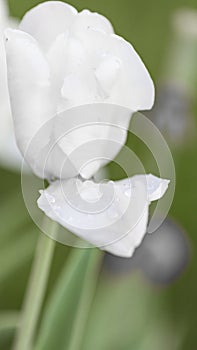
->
<box><xmin>35</xmin><ymin>249</ymin><xmax>101</xmax><ymax>350</ymax></box>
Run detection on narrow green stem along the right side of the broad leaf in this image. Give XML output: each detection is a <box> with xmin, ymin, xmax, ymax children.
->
<box><xmin>68</xmin><ymin>249</ymin><xmax>103</xmax><ymax>350</ymax></box>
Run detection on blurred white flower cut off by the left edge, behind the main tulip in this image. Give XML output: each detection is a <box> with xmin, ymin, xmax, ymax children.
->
<box><xmin>0</xmin><ymin>0</ymin><xmax>21</xmax><ymax>169</ymax></box>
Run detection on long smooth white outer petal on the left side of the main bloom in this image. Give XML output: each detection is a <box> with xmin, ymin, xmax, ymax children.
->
<box><xmin>5</xmin><ymin>29</ymin><xmax>55</xmax><ymax>175</ymax></box>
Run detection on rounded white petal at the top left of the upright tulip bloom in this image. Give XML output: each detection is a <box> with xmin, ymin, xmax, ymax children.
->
<box><xmin>20</xmin><ymin>1</ymin><xmax>77</xmax><ymax>51</ymax></box>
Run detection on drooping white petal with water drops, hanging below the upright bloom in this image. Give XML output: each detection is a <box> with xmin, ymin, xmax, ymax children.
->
<box><xmin>38</xmin><ymin>176</ymin><xmax>169</xmax><ymax>257</ymax></box>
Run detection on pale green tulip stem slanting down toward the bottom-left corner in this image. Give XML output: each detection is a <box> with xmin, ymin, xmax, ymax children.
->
<box><xmin>13</xmin><ymin>216</ymin><xmax>58</xmax><ymax>350</ymax></box>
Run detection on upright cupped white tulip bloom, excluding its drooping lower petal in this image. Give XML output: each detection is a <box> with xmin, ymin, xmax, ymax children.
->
<box><xmin>6</xmin><ymin>1</ymin><xmax>154</xmax><ymax>178</ymax></box>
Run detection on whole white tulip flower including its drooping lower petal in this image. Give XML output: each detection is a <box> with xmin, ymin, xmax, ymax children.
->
<box><xmin>5</xmin><ymin>1</ymin><xmax>168</xmax><ymax>257</ymax></box>
